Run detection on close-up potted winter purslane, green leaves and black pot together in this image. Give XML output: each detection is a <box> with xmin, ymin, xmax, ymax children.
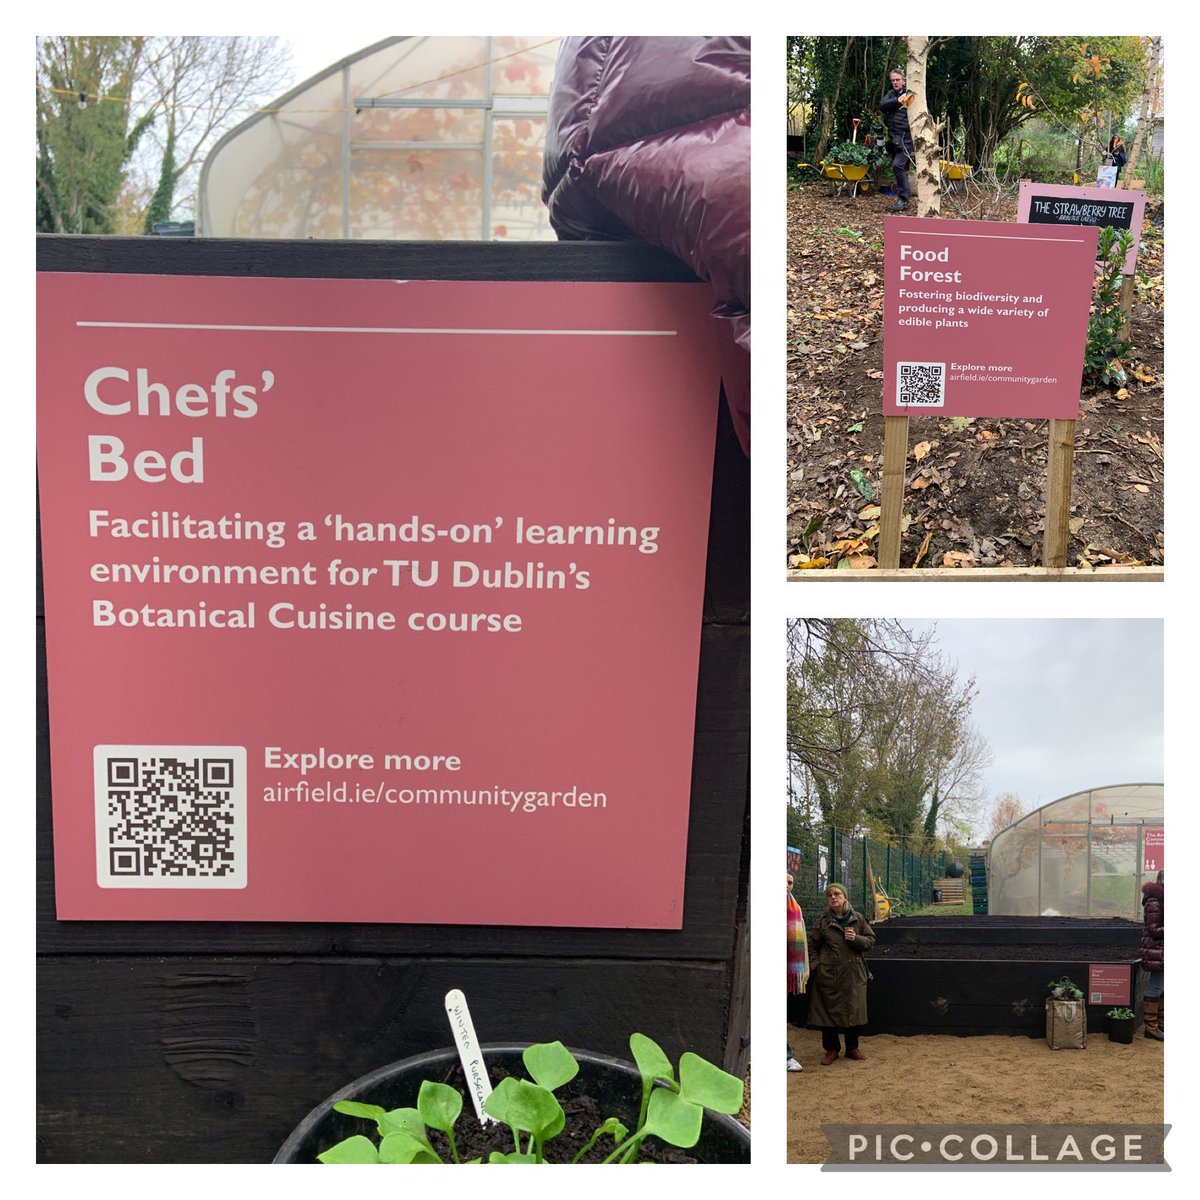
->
<box><xmin>275</xmin><ymin>1033</ymin><xmax>750</xmax><ymax>1165</ymax></box>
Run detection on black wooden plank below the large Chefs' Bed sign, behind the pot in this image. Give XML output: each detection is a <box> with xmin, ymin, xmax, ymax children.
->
<box><xmin>37</xmin><ymin>958</ymin><xmax>728</xmax><ymax>1163</ymax></box>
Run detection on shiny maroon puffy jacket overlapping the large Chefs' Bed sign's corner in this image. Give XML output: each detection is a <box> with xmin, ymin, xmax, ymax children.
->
<box><xmin>542</xmin><ymin>37</ymin><xmax>750</xmax><ymax>454</ymax></box>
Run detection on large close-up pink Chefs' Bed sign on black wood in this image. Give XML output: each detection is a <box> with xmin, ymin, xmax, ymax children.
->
<box><xmin>37</xmin><ymin>274</ymin><xmax>718</xmax><ymax>929</ymax></box>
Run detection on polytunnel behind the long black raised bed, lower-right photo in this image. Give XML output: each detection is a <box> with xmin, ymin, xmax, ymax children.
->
<box><xmin>988</xmin><ymin>784</ymin><xmax>1163</xmax><ymax>920</ymax></box>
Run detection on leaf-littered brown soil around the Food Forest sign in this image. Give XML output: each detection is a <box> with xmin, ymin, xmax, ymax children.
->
<box><xmin>787</xmin><ymin>184</ymin><xmax>1164</xmax><ymax>569</ymax></box>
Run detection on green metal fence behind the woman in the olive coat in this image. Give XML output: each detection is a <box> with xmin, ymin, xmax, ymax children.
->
<box><xmin>787</xmin><ymin>826</ymin><xmax>946</xmax><ymax>919</ymax></box>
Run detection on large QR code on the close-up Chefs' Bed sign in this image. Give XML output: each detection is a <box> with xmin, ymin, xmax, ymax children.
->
<box><xmin>94</xmin><ymin>746</ymin><xmax>246</xmax><ymax>888</ymax></box>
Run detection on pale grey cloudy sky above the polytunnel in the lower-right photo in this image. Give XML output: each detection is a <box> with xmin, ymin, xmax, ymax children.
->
<box><xmin>902</xmin><ymin>618</ymin><xmax>1163</xmax><ymax>823</ymax></box>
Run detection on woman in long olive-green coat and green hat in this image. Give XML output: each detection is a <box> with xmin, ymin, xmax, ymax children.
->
<box><xmin>809</xmin><ymin>883</ymin><xmax>875</xmax><ymax>1067</ymax></box>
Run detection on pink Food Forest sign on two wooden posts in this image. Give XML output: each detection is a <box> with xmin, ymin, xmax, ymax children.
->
<box><xmin>883</xmin><ymin>217</ymin><xmax>1097</xmax><ymax>420</ymax></box>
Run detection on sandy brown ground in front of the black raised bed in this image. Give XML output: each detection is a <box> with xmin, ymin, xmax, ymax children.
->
<box><xmin>787</xmin><ymin>1025</ymin><xmax>1165</xmax><ymax>1163</ymax></box>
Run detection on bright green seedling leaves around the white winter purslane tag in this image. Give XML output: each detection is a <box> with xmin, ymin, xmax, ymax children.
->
<box><xmin>317</xmin><ymin>1033</ymin><xmax>743</xmax><ymax>1165</ymax></box>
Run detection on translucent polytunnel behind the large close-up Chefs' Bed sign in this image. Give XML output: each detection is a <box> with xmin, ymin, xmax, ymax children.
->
<box><xmin>197</xmin><ymin>37</ymin><xmax>559</xmax><ymax>241</ymax></box>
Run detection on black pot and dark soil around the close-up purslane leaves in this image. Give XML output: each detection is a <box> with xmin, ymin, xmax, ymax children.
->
<box><xmin>274</xmin><ymin>1045</ymin><xmax>750</xmax><ymax>1163</ymax></box>
